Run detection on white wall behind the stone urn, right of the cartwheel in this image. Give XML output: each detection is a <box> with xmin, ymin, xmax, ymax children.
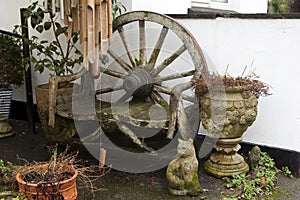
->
<box><xmin>179</xmin><ymin>18</ymin><xmax>300</xmax><ymax>152</ymax></box>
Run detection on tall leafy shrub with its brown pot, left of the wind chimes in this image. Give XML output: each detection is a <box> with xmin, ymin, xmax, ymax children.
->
<box><xmin>15</xmin><ymin>2</ymin><xmax>83</xmax><ymax>143</ymax></box>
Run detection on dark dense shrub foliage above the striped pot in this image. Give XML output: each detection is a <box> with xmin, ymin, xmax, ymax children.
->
<box><xmin>0</xmin><ymin>33</ymin><xmax>24</xmax><ymax>88</ymax></box>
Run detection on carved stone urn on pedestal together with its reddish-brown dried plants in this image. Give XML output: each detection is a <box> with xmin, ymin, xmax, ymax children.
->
<box><xmin>192</xmin><ymin>70</ymin><xmax>270</xmax><ymax>177</ymax></box>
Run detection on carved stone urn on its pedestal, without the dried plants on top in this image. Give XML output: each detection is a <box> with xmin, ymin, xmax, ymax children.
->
<box><xmin>200</xmin><ymin>87</ymin><xmax>258</xmax><ymax>177</ymax></box>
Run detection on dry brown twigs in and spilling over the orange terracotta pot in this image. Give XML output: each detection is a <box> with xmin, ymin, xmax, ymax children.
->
<box><xmin>14</xmin><ymin>146</ymin><xmax>111</xmax><ymax>196</ymax></box>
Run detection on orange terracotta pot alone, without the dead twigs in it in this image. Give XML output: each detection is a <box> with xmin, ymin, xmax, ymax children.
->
<box><xmin>16</xmin><ymin>165</ymin><xmax>78</xmax><ymax>200</ymax></box>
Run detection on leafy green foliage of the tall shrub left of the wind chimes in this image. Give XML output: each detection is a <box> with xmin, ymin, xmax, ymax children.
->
<box><xmin>15</xmin><ymin>1</ymin><xmax>83</xmax><ymax>75</ymax></box>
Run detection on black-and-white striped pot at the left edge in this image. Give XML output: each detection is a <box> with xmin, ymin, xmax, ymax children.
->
<box><xmin>0</xmin><ymin>88</ymin><xmax>12</xmax><ymax>117</ymax></box>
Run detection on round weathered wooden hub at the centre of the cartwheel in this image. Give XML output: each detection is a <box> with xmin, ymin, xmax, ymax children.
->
<box><xmin>123</xmin><ymin>69</ymin><xmax>154</xmax><ymax>97</ymax></box>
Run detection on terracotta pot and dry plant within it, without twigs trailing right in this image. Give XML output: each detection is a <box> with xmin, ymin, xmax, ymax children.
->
<box><xmin>16</xmin><ymin>149</ymin><xmax>78</xmax><ymax>200</ymax></box>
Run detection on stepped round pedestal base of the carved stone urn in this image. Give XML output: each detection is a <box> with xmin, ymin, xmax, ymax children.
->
<box><xmin>204</xmin><ymin>137</ymin><xmax>249</xmax><ymax>178</ymax></box>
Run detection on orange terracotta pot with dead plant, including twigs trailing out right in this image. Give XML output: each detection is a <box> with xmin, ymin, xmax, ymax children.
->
<box><xmin>15</xmin><ymin>147</ymin><xmax>109</xmax><ymax>200</ymax></box>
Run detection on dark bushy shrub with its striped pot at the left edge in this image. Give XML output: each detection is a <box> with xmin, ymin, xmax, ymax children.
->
<box><xmin>0</xmin><ymin>33</ymin><xmax>24</xmax><ymax>117</ymax></box>
